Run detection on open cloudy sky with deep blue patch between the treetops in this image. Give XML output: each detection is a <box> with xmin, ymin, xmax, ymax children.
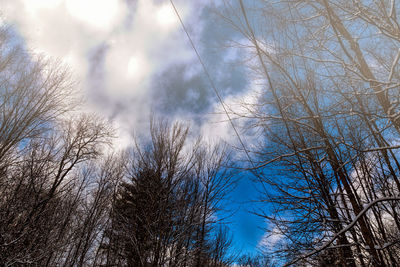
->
<box><xmin>0</xmin><ymin>0</ymin><xmax>268</xmax><ymax>258</ymax></box>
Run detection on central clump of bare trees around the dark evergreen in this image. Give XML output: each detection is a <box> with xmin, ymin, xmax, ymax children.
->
<box><xmin>103</xmin><ymin>122</ymin><xmax>236</xmax><ymax>266</ymax></box>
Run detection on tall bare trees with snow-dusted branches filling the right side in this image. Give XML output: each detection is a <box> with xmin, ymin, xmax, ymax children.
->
<box><xmin>225</xmin><ymin>0</ymin><xmax>400</xmax><ymax>266</ymax></box>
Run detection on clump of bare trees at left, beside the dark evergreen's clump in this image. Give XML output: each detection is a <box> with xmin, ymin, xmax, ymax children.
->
<box><xmin>0</xmin><ymin>22</ymin><xmax>122</xmax><ymax>266</ymax></box>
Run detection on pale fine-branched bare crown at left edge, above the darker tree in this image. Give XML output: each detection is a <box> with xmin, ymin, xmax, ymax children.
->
<box><xmin>0</xmin><ymin>26</ymin><xmax>74</xmax><ymax>166</ymax></box>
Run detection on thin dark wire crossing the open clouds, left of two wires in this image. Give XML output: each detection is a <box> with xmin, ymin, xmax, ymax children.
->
<box><xmin>170</xmin><ymin>0</ymin><xmax>256</xmax><ymax>169</ymax></box>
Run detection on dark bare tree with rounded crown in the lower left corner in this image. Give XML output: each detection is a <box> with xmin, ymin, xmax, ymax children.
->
<box><xmin>0</xmin><ymin>116</ymin><xmax>110</xmax><ymax>266</ymax></box>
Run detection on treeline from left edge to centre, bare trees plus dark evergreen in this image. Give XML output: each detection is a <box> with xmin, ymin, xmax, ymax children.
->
<box><xmin>0</xmin><ymin>26</ymin><xmax>233</xmax><ymax>266</ymax></box>
